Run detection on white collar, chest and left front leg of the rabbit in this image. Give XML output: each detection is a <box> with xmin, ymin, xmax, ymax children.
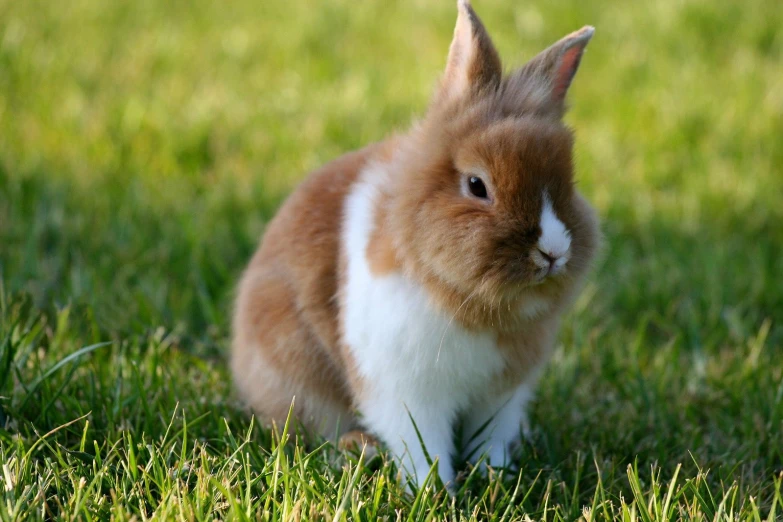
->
<box><xmin>342</xmin><ymin>161</ymin><xmax>505</xmax><ymax>483</ymax></box>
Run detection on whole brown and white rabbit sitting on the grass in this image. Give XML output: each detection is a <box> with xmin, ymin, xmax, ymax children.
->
<box><xmin>231</xmin><ymin>0</ymin><xmax>599</xmax><ymax>483</ymax></box>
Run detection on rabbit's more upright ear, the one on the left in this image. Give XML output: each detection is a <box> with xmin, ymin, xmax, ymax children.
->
<box><xmin>437</xmin><ymin>0</ymin><xmax>503</xmax><ymax>101</ymax></box>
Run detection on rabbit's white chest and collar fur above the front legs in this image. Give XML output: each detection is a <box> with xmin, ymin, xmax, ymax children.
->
<box><xmin>342</xmin><ymin>167</ymin><xmax>504</xmax><ymax>415</ymax></box>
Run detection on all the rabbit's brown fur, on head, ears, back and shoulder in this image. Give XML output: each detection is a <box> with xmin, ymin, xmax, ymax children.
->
<box><xmin>232</xmin><ymin>2</ymin><xmax>599</xmax><ymax>435</ymax></box>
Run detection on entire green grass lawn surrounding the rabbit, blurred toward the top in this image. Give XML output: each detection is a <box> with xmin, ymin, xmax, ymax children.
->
<box><xmin>0</xmin><ymin>0</ymin><xmax>783</xmax><ymax>521</ymax></box>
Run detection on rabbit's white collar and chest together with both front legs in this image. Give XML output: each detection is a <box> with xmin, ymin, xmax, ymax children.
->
<box><xmin>340</xmin><ymin>152</ymin><xmax>555</xmax><ymax>480</ymax></box>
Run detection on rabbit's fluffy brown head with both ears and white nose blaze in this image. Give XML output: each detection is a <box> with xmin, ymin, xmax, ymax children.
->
<box><xmin>388</xmin><ymin>0</ymin><xmax>598</xmax><ymax>312</ymax></box>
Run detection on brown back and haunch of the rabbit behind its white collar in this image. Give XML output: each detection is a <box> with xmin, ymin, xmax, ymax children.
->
<box><xmin>232</xmin><ymin>145</ymin><xmax>379</xmax><ymax>433</ymax></box>
